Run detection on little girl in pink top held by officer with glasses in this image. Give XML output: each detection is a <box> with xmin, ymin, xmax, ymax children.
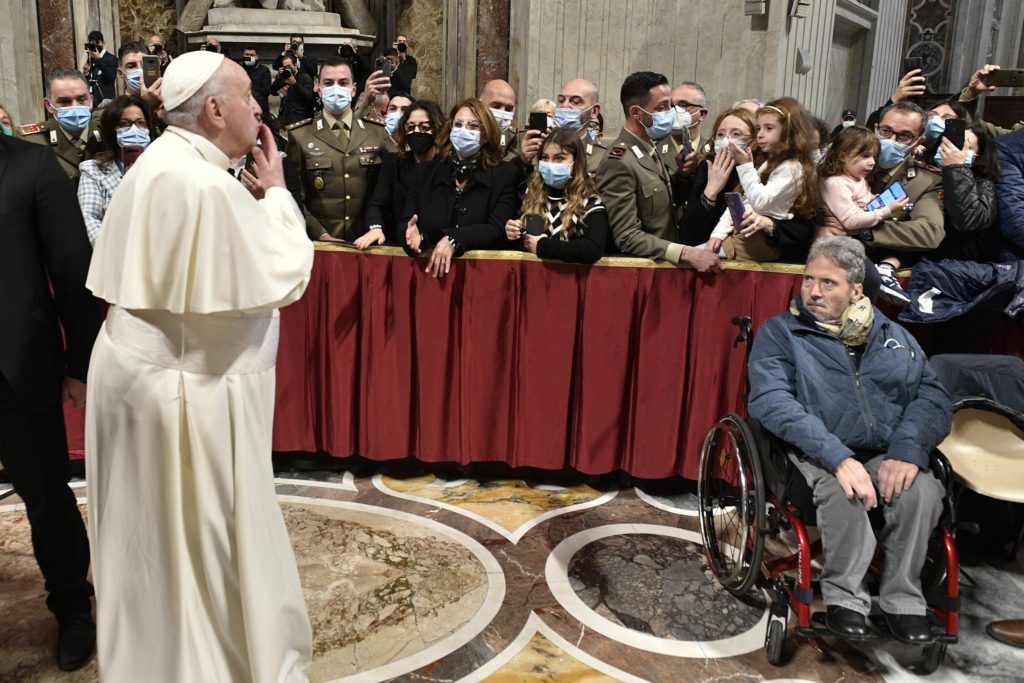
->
<box><xmin>818</xmin><ymin>126</ymin><xmax>907</xmax><ymax>234</ymax></box>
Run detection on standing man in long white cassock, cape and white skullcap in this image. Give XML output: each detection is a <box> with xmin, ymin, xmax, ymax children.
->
<box><xmin>86</xmin><ymin>52</ymin><xmax>313</xmax><ymax>683</ymax></box>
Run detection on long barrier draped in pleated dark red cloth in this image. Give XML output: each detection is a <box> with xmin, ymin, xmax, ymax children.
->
<box><xmin>68</xmin><ymin>246</ymin><xmax>1024</xmax><ymax>478</ymax></box>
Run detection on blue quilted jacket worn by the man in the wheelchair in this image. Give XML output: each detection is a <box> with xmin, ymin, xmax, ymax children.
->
<box><xmin>748</xmin><ymin>309</ymin><xmax>952</xmax><ymax>472</ymax></box>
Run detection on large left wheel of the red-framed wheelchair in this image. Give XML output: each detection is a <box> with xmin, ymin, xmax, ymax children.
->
<box><xmin>697</xmin><ymin>414</ymin><xmax>765</xmax><ymax>596</ymax></box>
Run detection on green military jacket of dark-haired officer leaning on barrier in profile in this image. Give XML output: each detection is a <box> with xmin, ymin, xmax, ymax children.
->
<box><xmin>597</xmin><ymin>128</ymin><xmax>683</xmax><ymax>263</ymax></box>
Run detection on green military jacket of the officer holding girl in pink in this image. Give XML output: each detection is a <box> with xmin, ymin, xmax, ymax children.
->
<box><xmin>870</xmin><ymin>159</ymin><xmax>946</xmax><ymax>251</ymax></box>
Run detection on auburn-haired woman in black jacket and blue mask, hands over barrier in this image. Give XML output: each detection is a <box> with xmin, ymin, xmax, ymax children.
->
<box><xmin>402</xmin><ymin>97</ymin><xmax>522</xmax><ymax>278</ymax></box>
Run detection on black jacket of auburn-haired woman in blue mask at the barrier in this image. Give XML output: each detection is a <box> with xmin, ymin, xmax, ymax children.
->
<box><xmin>399</xmin><ymin>159</ymin><xmax>522</xmax><ymax>251</ymax></box>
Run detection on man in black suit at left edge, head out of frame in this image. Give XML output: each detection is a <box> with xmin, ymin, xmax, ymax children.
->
<box><xmin>0</xmin><ymin>129</ymin><xmax>100</xmax><ymax>671</ymax></box>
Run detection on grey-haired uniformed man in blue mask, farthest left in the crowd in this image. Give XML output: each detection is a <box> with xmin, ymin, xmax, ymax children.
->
<box><xmin>17</xmin><ymin>69</ymin><xmax>102</xmax><ymax>186</ymax></box>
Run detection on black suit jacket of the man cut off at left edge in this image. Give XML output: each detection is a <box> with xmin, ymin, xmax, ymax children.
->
<box><xmin>0</xmin><ymin>135</ymin><xmax>100</xmax><ymax>413</ymax></box>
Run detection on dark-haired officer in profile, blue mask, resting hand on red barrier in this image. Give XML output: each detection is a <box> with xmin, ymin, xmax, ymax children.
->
<box><xmin>597</xmin><ymin>72</ymin><xmax>722</xmax><ymax>272</ymax></box>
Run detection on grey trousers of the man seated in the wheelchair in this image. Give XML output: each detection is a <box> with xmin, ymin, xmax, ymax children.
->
<box><xmin>791</xmin><ymin>456</ymin><xmax>943</xmax><ymax>614</ymax></box>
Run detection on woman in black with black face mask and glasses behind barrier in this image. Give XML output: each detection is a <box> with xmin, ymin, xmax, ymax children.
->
<box><xmin>355</xmin><ymin>99</ymin><xmax>444</xmax><ymax>249</ymax></box>
